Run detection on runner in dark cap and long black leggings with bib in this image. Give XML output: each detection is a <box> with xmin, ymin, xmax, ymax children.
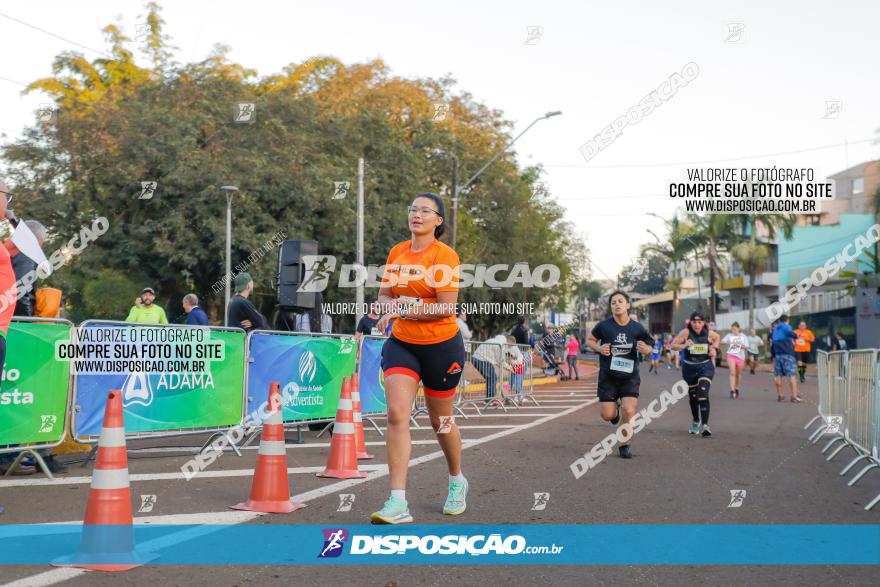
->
<box><xmin>672</xmin><ymin>312</ymin><xmax>721</xmax><ymax>436</ymax></box>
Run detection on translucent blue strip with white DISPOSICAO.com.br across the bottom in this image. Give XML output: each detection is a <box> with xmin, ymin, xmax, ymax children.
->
<box><xmin>0</xmin><ymin>524</ymin><xmax>880</xmax><ymax>565</ymax></box>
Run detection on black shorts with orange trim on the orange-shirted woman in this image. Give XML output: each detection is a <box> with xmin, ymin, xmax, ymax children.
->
<box><xmin>382</xmin><ymin>332</ymin><xmax>464</xmax><ymax>398</ymax></box>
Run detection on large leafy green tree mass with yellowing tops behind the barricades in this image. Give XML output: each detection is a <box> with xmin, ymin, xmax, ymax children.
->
<box><xmin>0</xmin><ymin>3</ymin><xmax>584</xmax><ymax>331</ymax></box>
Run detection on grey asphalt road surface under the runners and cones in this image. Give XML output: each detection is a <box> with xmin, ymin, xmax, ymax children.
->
<box><xmin>0</xmin><ymin>367</ymin><xmax>880</xmax><ymax>587</ymax></box>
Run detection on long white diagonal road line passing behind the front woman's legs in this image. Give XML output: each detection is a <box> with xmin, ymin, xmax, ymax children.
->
<box><xmin>0</xmin><ymin>400</ymin><xmax>596</xmax><ymax>587</ymax></box>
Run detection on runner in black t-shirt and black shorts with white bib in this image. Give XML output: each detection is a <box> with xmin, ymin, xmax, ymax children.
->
<box><xmin>588</xmin><ymin>291</ymin><xmax>654</xmax><ymax>459</ymax></box>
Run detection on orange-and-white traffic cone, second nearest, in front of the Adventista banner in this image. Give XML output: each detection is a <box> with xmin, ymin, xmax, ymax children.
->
<box><xmin>229</xmin><ymin>382</ymin><xmax>306</xmax><ymax>514</ymax></box>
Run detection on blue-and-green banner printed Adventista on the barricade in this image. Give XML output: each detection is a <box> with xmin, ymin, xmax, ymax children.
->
<box><xmin>247</xmin><ymin>333</ymin><xmax>357</xmax><ymax>422</ymax></box>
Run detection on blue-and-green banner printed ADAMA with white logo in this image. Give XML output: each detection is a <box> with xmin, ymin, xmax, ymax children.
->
<box><xmin>70</xmin><ymin>323</ymin><xmax>245</xmax><ymax>438</ymax></box>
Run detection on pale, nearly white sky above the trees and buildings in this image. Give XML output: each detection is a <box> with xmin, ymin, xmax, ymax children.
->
<box><xmin>0</xmin><ymin>0</ymin><xmax>880</xmax><ymax>277</ymax></box>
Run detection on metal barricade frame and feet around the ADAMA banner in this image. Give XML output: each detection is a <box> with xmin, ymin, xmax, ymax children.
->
<box><xmin>71</xmin><ymin>319</ymin><xmax>248</xmax><ymax>467</ymax></box>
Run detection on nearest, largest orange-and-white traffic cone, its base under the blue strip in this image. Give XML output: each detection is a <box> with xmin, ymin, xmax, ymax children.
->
<box><xmin>52</xmin><ymin>389</ymin><xmax>156</xmax><ymax>571</ymax></box>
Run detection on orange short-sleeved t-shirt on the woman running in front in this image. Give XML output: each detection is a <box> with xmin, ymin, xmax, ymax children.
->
<box><xmin>382</xmin><ymin>240</ymin><xmax>461</xmax><ymax>344</ymax></box>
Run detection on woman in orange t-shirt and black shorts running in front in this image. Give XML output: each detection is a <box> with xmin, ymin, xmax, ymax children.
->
<box><xmin>371</xmin><ymin>192</ymin><xmax>468</xmax><ymax>524</ymax></box>
